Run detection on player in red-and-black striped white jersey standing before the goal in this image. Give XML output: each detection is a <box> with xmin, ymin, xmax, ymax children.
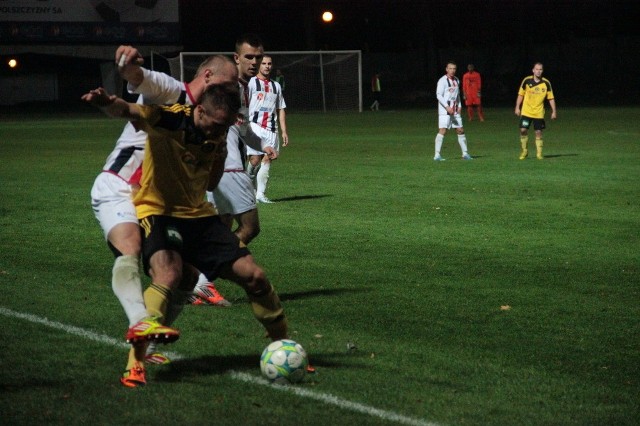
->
<box><xmin>247</xmin><ymin>55</ymin><xmax>289</xmax><ymax>203</ymax></box>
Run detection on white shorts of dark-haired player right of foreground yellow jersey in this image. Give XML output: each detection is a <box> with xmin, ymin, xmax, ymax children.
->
<box><xmin>207</xmin><ymin>170</ymin><xmax>256</xmax><ymax>215</ymax></box>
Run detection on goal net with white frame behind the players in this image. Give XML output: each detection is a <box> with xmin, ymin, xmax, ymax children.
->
<box><xmin>152</xmin><ymin>50</ymin><xmax>362</xmax><ymax>112</ymax></box>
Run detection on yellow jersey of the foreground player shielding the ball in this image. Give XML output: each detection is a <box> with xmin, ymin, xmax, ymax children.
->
<box><xmin>133</xmin><ymin>104</ymin><xmax>226</xmax><ymax>219</ymax></box>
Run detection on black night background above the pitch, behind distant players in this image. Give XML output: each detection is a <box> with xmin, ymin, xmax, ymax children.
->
<box><xmin>0</xmin><ymin>0</ymin><xmax>640</xmax><ymax>108</ymax></box>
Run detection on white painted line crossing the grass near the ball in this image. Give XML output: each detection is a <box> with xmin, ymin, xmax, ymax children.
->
<box><xmin>0</xmin><ymin>306</ymin><xmax>439</xmax><ymax>426</ymax></box>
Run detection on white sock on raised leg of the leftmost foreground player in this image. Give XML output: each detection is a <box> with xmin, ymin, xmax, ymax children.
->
<box><xmin>111</xmin><ymin>255</ymin><xmax>148</xmax><ymax>327</ymax></box>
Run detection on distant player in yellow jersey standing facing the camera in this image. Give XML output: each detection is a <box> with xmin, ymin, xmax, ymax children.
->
<box><xmin>515</xmin><ymin>62</ymin><xmax>557</xmax><ymax>160</ymax></box>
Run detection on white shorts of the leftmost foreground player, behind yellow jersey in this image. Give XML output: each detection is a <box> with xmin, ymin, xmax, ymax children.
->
<box><xmin>91</xmin><ymin>172</ymin><xmax>138</xmax><ymax>239</ymax></box>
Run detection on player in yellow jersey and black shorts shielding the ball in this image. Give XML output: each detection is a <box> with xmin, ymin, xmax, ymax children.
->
<box><xmin>82</xmin><ymin>83</ymin><xmax>288</xmax><ymax>387</ymax></box>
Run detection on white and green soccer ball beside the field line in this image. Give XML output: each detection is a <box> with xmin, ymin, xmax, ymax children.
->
<box><xmin>260</xmin><ymin>339</ymin><xmax>309</xmax><ymax>384</ymax></box>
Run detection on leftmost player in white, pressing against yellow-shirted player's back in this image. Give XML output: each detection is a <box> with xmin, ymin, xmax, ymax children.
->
<box><xmin>91</xmin><ymin>46</ymin><xmax>237</xmax><ymax>370</ymax></box>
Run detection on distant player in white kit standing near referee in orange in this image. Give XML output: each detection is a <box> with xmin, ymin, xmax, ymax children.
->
<box><xmin>433</xmin><ymin>61</ymin><xmax>472</xmax><ymax>161</ymax></box>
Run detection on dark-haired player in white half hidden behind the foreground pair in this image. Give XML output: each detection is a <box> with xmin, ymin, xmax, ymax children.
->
<box><xmin>207</xmin><ymin>34</ymin><xmax>277</xmax><ymax>244</ymax></box>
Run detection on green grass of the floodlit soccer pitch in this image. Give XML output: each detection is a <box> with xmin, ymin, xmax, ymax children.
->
<box><xmin>0</xmin><ymin>108</ymin><xmax>640</xmax><ymax>425</ymax></box>
